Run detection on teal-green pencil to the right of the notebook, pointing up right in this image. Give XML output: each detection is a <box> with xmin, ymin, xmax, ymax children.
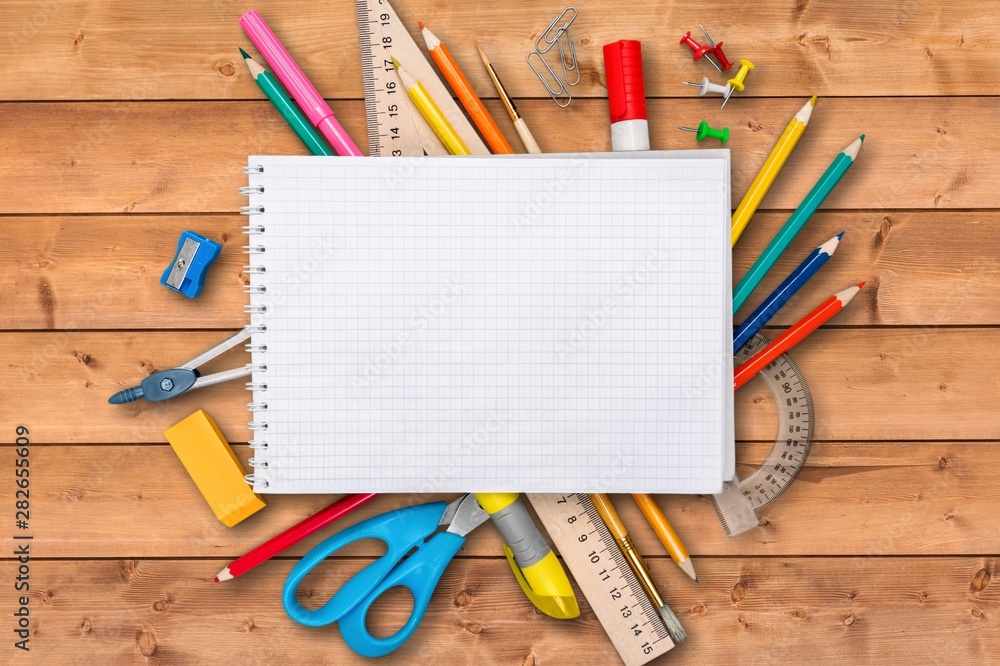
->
<box><xmin>733</xmin><ymin>134</ymin><xmax>865</xmax><ymax>314</ymax></box>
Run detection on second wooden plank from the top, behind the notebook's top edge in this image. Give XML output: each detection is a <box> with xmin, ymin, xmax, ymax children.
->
<box><xmin>0</xmin><ymin>97</ymin><xmax>988</xmax><ymax>214</ymax></box>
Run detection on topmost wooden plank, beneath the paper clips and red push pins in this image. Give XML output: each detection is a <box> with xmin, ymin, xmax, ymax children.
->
<box><xmin>0</xmin><ymin>0</ymin><xmax>1000</xmax><ymax>100</ymax></box>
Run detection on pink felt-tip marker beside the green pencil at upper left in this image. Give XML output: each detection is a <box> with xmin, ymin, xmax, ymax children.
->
<box><xmin>240</xmin><ymin>9</ymin><xmax>362</xmax><ymax>156</ymax></box>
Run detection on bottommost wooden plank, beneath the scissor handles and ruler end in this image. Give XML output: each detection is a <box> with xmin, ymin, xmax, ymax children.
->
<box><xmin>0</xmin><ymin>557</ymin><xmax>1000</xmax><ymax>664</ymax></box>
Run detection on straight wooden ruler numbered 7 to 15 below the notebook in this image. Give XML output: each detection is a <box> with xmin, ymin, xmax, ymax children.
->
<box><xmin>528</xmin><ymin>493</ymin><xmax>674</xmax><ymax>666</ymax></box>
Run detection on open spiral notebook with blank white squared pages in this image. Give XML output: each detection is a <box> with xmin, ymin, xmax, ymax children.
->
<box><xmin>242</xmin><ymin>150</ymin><xmax>734</xmax><ymax>493</ymax></box>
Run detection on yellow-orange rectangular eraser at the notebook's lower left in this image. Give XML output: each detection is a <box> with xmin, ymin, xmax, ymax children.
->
<box><xmin>163</xmin><ymin>409</ymin><xmax>265</xmax><ymax>527</ymax></box>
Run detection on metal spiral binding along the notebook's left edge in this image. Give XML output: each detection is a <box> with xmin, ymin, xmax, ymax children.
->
<box><xmin>240</xmin><ymin>164</ymin><xmax>268</xmax><ymax>489</ymax></box>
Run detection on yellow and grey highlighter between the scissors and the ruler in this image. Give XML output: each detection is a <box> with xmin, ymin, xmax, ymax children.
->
<box><xmin>476</xmin><ymin>493</ymin><xmax>580</xmax><ymax>620</ymax></box>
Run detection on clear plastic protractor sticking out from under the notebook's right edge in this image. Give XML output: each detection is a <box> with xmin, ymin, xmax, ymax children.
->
<box><xmin>712</xmin><ymin>333</ymin><xmax>816</xmax><ymax>537</ymax></box>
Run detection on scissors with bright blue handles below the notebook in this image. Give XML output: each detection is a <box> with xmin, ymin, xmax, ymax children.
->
<box><xmin>282</xmin><ymin>493</ymin><xmax>490</xmax><ymax>657</ymax></box>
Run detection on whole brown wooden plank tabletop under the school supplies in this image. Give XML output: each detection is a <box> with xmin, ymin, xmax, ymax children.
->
<box><xmin>0</xmin><ymin>0</ymin><xmax>1000</xmax><ymax>664</ymax></box>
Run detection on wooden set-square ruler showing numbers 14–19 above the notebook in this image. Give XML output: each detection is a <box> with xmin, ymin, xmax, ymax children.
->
<box><xmin>356</xmin><ymin>0</ymin><xmax>490</xmax><ymax>157</ymax></box>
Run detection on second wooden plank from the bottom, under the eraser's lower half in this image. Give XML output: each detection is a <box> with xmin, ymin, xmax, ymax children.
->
<box><xmin>0</xmin><ymin>442</ymin><xmax>1000</xmax><ymax>560</ymax></box>
